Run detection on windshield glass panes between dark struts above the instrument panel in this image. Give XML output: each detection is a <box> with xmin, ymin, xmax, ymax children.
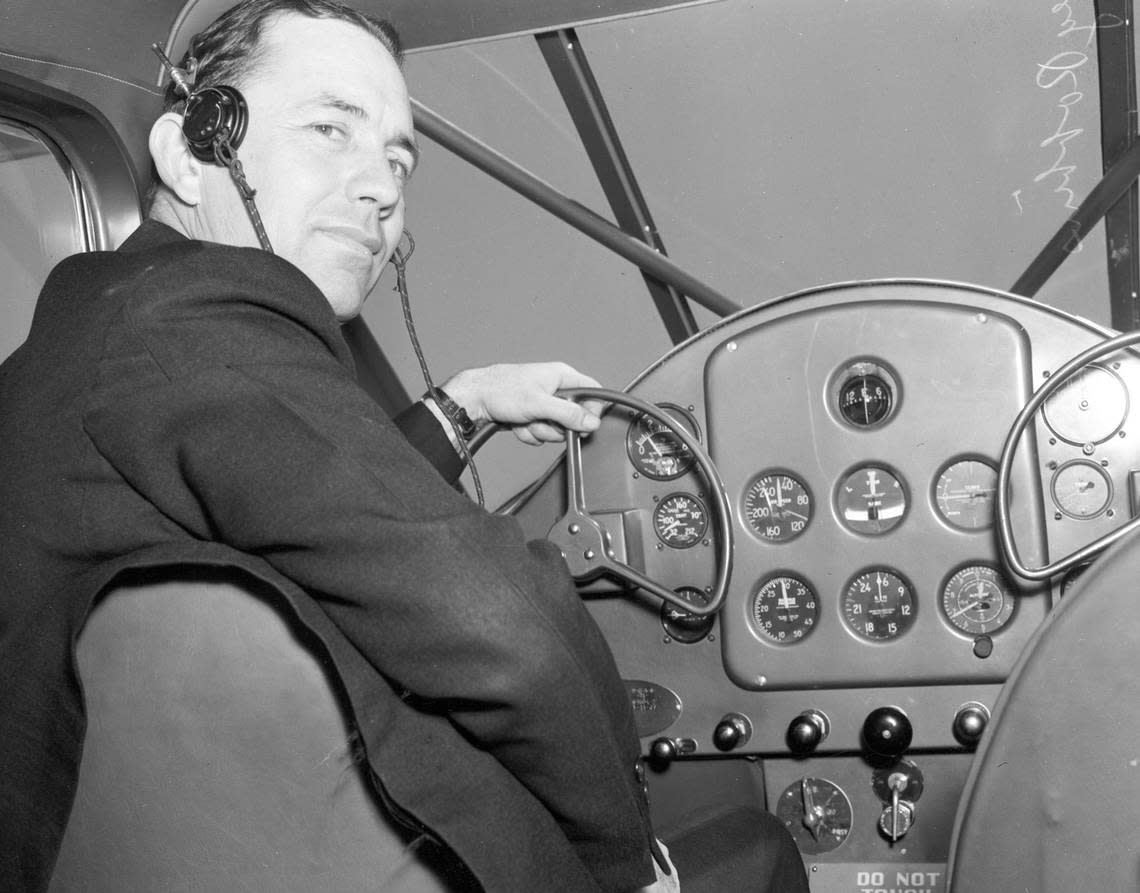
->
<box><xmin>367</xmin><ymin>0</ymin><xmax>1112</xmax><ymax>501</ymax></box>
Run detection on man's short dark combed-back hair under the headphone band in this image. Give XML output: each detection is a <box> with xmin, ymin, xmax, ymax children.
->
<box><xmin>143</xmin><ymin>0</ymin><xmax>404</xmax><ymax>212</ymax></box>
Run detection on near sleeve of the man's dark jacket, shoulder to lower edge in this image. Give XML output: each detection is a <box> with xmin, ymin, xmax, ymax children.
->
<box><xmin>84</xmin><ymin>285</ymin><xmax>653</xmax><ymax>891</ymax></box>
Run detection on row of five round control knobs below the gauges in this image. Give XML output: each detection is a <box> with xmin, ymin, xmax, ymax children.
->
<box><xmin>650</xmin><ymin>701</ymin><xmax>990</xmax><ymax>764</ymax></box>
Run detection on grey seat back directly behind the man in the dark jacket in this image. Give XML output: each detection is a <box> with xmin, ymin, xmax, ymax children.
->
<box><xmin>51</xmin><ymin>579</ymin><xmax>458</xmax><ymax>893</ymax></box>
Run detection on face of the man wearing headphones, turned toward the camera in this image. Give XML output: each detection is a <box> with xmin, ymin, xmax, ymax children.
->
<box><xmin>198</xmin><ymin>14</ymin><xmax>416</xmax><ymax>320</ymax></box>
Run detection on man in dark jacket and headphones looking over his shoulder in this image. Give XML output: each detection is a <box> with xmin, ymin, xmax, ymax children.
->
<box><xmin>0</xmin><ymin>0</ymin><xmax>806</xmax><ymax>891</ymax></box>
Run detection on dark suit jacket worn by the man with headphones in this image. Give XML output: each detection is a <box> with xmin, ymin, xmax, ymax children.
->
<box><xmin>0</xmin><ymin>222</ymin><xmax>653</xmax><ymax>891</ymax></box>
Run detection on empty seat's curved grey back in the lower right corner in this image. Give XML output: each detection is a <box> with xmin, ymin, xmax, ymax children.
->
<box><xmin>947</xmin><ymin>535</ymin><xmax>1140</xmax><ymax>893</ymax></box>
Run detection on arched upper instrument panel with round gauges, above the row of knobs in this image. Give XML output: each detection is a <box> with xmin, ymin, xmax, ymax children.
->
<box><xmin>519</xmin><ymin>282</ymin><xmax>1140</xmax><ymax>716</ymax></box>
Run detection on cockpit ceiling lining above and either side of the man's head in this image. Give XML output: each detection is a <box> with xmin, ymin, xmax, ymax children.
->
<box><xmin>0</xmin><ymin>0</ymin><xmax>716</xmax><ymax>86</ymax></box>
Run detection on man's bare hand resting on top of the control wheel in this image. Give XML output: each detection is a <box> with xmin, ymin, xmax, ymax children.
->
<box><xmin>442</xmin><ymin>363</ymin><xmax>602</xmax><ymax>446</ymax></box>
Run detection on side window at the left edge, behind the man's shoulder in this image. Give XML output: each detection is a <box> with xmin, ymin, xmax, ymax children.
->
<box><xmin>0</xmin><ymin>119</ymin><xmax>89</xmax><ymax>360</ymax></box>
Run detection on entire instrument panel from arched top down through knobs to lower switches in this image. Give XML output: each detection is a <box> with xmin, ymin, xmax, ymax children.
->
<box><xmin>516</xmin><ymin>281</ymin><xmax>1140</xmax><ymax>891</ymax></box>
